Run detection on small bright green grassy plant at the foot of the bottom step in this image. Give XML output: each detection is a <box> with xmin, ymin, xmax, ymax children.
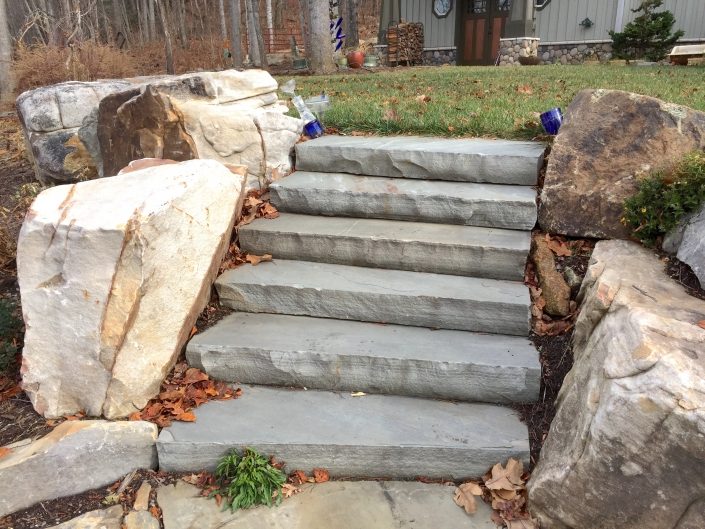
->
<box><xmin>211</xmin><ymin>448</ymin><xmax>286</xmax><ymax>511</ymax></box>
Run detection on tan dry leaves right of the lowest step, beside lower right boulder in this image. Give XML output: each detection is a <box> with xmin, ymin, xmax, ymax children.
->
<box><xmin>453</xmin><ymin>458</ymin><xmax>539</xmax><ymax>529</ymax></box>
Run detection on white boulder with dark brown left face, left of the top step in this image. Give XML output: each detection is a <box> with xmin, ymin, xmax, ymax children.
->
<box><xmin>98</xmin><ymin>70</ymin><xmax>302</xmax><ymax>182</ymax></box>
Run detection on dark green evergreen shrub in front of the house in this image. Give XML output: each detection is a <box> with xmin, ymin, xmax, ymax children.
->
<box><xmin>609</xmin><ymin>0</ymin><xmax>684</xmax><ymax>61</ymax></box>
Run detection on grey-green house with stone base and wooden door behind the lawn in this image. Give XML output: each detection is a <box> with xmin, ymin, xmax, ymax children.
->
<box><xmin>380</xmin><ymin>0</ymin><xmax>705</xmax><ymax>64</ymax></box>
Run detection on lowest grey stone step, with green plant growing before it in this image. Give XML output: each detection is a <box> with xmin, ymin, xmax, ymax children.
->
<box><xmin>157</xmin><ymin>386</ymin><xmax>529</xmax><ymax>480</ymax></box>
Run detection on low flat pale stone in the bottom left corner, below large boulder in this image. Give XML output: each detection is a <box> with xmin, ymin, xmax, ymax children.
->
<box><xmin>0</xmin><ymin>421</ymin><xmax>157</xmax><ymax>516</ymax></box>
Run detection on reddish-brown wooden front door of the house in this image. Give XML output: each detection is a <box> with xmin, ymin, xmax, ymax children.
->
<box><xmin>460</xmin><ymin>0</ymin><xmax>512</xmax><ymax>64</ymax></box>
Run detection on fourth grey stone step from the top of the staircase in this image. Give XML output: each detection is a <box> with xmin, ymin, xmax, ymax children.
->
<box><xmin>216</xmin><ymin>259</ymin><xmax>530</xmax><ymax>336</ymax></box>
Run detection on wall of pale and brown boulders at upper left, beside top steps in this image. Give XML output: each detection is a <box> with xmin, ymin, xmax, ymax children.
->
<box><xmin>17</xmin><ymin>70</ymin><xmax>302</xmax><ymax>185</ymax></box>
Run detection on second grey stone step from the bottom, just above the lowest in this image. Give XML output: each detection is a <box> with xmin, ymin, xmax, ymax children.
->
<box><xmin>186</xmin><ymin>313</ymin><xmax>541</xmax><ymax>404</ymax></box>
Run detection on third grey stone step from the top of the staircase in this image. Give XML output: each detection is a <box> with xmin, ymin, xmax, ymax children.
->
<box><xmin>240</xmin><ymin>213</ymin><xmax>531</xmax><ymax>281</ymax></box>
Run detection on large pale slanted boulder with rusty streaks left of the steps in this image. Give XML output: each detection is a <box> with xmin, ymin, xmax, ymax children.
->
<box><xmin>17</xmin><ymin>160</ymin><xmax>245</xmax><ymax>418</ymax></box>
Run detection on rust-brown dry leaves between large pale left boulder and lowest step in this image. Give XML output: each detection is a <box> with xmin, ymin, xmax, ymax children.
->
<box><xmin>130</xmin><ymin>362</ymin><xmax>236</xmax><ymax>428</ymax></box>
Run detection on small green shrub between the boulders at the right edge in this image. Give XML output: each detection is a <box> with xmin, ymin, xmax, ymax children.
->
<box><xmin>622</xmin><ymin>151</ymin><xmax>705</xmax><ymax>246</ymax></box>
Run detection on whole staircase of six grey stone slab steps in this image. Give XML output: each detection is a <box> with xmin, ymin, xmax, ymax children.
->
<box><xmin>158</xmin><ymin>136</ymin><xmax>543</xmax><ymax>479</ymax></box>
